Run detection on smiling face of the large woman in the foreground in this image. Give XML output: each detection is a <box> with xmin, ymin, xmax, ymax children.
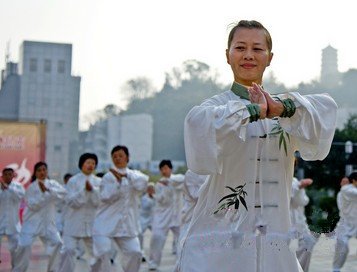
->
<box><xmin>226</xmin><ymin>27</ymin><xmax>273</xmax><ymax>86</ymax></box>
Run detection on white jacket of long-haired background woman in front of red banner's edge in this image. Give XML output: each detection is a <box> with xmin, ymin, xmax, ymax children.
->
<box><xmin>21</xmin><ymin>179</ymin><xmax>66</xmax><ymax>236</ymax></box>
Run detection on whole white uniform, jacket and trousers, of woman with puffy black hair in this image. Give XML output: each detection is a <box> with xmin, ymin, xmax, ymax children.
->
<box><xmin>59</xmin><ymin>172</ymin><xmax>101</xmax><ymax>272</ymax></box>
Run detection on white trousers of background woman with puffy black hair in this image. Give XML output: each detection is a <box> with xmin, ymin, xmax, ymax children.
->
<box><xmin>58</xmin><ymin>235</ymin><xmax>99</xmax><ymax>272</ymax></box>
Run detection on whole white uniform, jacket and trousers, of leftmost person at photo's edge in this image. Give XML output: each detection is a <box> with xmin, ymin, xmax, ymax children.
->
<box><xmin>0</xmin><ymin>181</ymin><xmax>25</xmax><ymax>267</ymax></box>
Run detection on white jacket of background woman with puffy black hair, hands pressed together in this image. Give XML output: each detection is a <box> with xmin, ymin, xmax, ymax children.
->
<box><xmin>63</xmin><ymin>172</ymin><xmax>101</xmax><ymax>237</ymax></box>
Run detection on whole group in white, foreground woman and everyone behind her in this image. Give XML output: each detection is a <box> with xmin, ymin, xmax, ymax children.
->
<box><xmin>0</xmin><ymin>20</ymin><xmax>357</xmax><ymax>272</ymax></box>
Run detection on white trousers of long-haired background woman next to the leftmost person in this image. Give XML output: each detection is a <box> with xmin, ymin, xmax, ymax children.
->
<box><xmin>12</xmin><ymin>232</ymin><xmax>62</xmax><ymax>272</ymax></box>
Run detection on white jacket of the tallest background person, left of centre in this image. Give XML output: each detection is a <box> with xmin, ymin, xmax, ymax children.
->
<box><xmin>93</xmin><ymin>168</ymin><xmax>149</xmax><ymax>237</ymax></box>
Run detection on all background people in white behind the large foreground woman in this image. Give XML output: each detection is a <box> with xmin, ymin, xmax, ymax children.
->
<box><xmin>0</xmin><ymin>153</ymin><xmax>357</xmax><ymax>272</ymax></box>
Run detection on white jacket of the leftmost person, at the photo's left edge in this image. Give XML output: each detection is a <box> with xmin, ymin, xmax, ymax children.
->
<box><xmin>0</xmin><ymin>181</ymin><xmax>25</xmax><ymax>235</ymax></box>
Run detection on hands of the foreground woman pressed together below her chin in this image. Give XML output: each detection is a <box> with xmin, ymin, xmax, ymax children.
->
<box><xmin>248</xmin><ymin>82</ymin><xmax>284</xmax><ymax>119</ymax></box>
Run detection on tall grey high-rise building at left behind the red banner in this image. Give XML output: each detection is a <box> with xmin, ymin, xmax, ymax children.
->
<box><xmin>0</xmin><ymin>41</ymin><xmax>81</xmax><ymax>179</ymax></box>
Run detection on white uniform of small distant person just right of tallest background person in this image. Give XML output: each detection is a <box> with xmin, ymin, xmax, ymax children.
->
<box><xmin>139</xmin><ymin>193</ymin><xmax>155</xmax><ymax>252</ymax></box>
